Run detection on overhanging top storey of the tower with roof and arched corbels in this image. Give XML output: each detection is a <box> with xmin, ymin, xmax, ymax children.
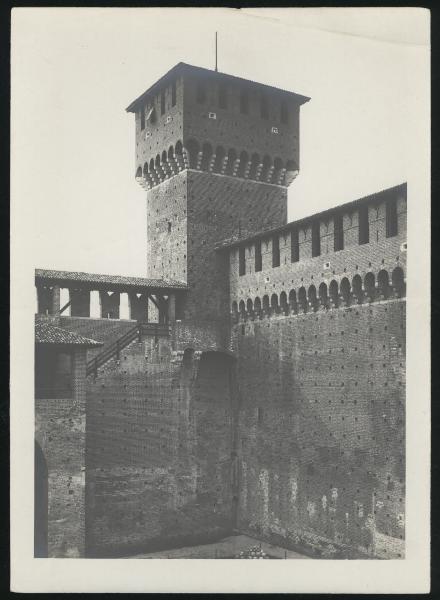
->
<box><xmin>127</xmin><ymin>63</ymin><xmax>309</xmax><ymax>189</ymax></box>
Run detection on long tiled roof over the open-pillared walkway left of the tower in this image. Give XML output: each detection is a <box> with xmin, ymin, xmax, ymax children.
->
<box><xmin>35</xmin><ymin>269</ymin><xmax>187</xmax><ymax>289</ymax></box>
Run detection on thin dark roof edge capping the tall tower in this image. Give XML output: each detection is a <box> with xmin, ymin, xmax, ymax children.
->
<box><xmin>125</xmin><ymin>62</ymin><xmax>310</xmax><ymax>112</ymax></box>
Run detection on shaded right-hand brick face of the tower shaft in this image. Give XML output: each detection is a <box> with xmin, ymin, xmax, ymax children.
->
<box><xmin>185</xmin><ymin>171</ymin><xmax>287</xmax><ymax>321</ymax></box>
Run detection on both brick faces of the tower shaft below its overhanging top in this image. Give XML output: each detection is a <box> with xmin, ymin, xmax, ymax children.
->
<box><xmin>147</xmin><ymin>170</ymin><xmax>287</xmax><ymax>323</ymax></box>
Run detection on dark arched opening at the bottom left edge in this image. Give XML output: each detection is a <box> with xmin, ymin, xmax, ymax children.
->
<box><xmin>34</xmin><ymin>441</ymin><xmax>49</xmax><ymax>558</ymax></box>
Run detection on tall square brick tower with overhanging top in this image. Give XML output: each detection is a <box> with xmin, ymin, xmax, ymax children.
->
<box><xmin>127</xmin><ymin>63</ymin><xmax>309</xmax><ymax>322</ymax></box>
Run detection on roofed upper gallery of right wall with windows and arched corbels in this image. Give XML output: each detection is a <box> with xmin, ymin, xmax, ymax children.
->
<box><xmin>217</xmin><ymin>184</ymin><xmax>407</xmax><ymax>321</ymax></box>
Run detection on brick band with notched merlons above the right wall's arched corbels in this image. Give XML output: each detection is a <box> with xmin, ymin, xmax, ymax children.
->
<box><xmin>229</xmin><ymin>198</ymin><xmax>406</xmax><ymax>312</ymax></box>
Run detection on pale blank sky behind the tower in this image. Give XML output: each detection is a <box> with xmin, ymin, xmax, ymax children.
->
<box><xmin>12</xmin><ymin>8</ymin><xmax>429</xmax><ymax>276</ymax></box>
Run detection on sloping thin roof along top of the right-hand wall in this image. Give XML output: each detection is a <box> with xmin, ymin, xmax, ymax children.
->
<box><xmin>216</xmin><ymin>183</ymin><xmax>406</xmax><ymax>250</ymax></box>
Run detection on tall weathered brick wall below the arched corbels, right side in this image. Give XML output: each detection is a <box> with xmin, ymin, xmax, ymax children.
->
<box><xmin>232</xmin><ymin>300</ymin><xmax>405</xmax><ymax>558</ymax></box>
